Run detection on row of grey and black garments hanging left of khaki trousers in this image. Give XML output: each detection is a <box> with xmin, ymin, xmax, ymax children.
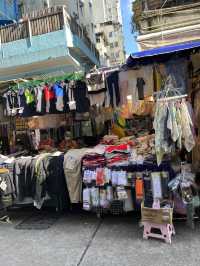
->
<box><xmin>0</xmin><ymin>152</ymin><xmax>68</xmax><ymax>209</ymax></box>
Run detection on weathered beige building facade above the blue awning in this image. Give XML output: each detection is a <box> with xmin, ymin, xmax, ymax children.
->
<box><xmin>133</xmin><ymin>0</ymin><xmax>200</xmax><ymax>50</ymax></box>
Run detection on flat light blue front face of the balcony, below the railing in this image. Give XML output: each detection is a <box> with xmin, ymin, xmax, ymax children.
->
<box><xmin>0</xmin><ymin>30</ymin><xmax>68</xmax><ymax>68</ymax></box>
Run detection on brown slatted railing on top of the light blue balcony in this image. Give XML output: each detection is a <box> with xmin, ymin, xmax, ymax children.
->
<box><xmin>0</xmin><ymin>7</ymin><xmax>99</xmax><ymax>59</ymax></box>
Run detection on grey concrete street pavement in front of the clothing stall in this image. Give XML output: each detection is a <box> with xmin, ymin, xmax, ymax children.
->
<box><xmin>0</xmin><ymin>210</ymin><xmax>200</xmax><ymax>266</ymax></box>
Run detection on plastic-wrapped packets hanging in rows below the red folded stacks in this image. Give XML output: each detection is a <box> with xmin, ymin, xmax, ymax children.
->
<box><xmin>83</xmin><ymin>164</ymin><xmax>133</xmax><ymax>213</ymax></box>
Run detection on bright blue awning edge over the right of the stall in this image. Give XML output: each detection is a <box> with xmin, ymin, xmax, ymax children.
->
<box><xmin>131</xmin><ymin>41</ymin><xmax>200</xmax><ymax>59</ymax></box>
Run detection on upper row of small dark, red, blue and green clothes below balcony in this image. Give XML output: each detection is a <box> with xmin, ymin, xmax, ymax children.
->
<box><xmin>3</xmin><ymin>77</ymin><xmax>90</xmax><ymax>117</ymax></box>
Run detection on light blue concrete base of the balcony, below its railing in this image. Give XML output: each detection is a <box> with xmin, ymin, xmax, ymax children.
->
<box><xmin>0</xmin><ymin>22</ymin><xmax>99</xmax><ymax>80</ymax></box>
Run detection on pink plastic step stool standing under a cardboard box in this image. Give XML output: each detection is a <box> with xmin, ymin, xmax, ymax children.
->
<box><xmin>142</xmin><ymin>222</ymin><xmax>175</xmax><ymax>244</ymax></box>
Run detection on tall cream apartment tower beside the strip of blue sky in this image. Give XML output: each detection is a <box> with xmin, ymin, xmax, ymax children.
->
<box><xmin>93</xmin><ymin>0</ymin><xmax>125</xmax><ymax>66</ymax></box>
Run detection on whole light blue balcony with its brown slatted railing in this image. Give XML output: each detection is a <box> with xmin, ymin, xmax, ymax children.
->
<box><xmin>0</xmin><ymin>7</ymin><xmax>99</xmax><ymax>80</ymax></box>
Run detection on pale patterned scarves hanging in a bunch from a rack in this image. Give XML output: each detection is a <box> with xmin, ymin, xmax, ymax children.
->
<box><xmin>154</xmin><ymin>78</ymin><xmax>195</xmax><ymax>165</ymax></box>
